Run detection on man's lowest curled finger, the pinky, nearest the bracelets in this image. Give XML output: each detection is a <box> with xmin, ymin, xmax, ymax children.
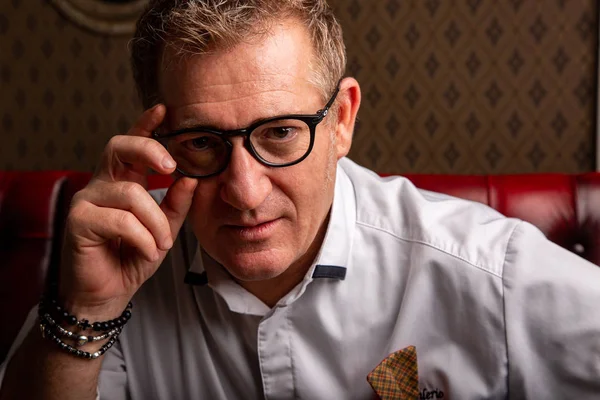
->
<box><xmin>68</xmin><ymin>202</ymin><xmax>160</xmax><ymax>262</ymax></box>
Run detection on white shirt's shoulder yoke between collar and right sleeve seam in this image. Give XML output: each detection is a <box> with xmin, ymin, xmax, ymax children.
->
<box><xmin>340</xmin><ymin>160</ymin><xmax>521</xmax><ymax>277</ymax></box>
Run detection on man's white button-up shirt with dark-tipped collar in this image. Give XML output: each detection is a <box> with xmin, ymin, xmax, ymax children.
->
<box><xmin>0</xmin><ymin>159</ymin><xmax>600</xmax><ymax>400</ymax></box>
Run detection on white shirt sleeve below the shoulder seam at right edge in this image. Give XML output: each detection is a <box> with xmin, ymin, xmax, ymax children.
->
<box><xmin>503</xmin><ymin>222</ymin><xmax>600</xmax><ymax>399</ymax></box>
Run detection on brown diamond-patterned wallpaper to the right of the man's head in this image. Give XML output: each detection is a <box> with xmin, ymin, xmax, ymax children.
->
<box><xmin>338</xmin><ymin>0</ymin><xmax>598</xmax><ymax>173</ymax></box>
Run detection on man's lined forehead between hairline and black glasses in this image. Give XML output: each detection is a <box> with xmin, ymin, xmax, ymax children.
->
<box><xmin>159</xmin><ymin>21</ymin><xmax>314</xmax><ymax>108</ymax></box>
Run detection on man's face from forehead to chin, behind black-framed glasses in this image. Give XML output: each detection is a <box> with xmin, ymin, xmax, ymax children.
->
<box><xmin>160</xmin><ymin>21</ymin><xmax>345</xmax><ymax>281</ymax></box>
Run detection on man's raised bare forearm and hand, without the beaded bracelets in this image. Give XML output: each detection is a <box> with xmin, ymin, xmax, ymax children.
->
<box><xmin>0</xmin><ymin>106</ymin><xmax>196</xmax><ymax>400</ymax></box>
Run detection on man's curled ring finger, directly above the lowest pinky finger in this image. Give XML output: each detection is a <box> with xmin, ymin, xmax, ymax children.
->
<box><xmin>81</xmin><ymin>181</ymin><xmax>173</xmax><ymax>250</ymax></box>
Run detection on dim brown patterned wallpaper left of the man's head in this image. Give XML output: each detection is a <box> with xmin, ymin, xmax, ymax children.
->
<box><xmin>0</xmin><ymin>0</ymin><xmax>141</xmax><ymax>171</ymax></box>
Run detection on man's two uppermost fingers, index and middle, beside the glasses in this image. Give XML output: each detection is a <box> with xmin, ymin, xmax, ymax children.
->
<box><xmin>96</xmin><ymin>104</ymin><xmax>176</xmax><ymax>184</ymax></box>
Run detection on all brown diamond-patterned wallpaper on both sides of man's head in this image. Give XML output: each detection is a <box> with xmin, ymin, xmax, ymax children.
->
<box><xmin>0</xmin><ymin>0</ymin><xmax>598</xmax><ymax>173</ymax></box>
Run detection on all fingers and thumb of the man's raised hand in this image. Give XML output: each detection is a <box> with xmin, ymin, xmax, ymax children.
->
<box><xmin>69</xmin><ymin>105</ymin><xmax>197</xmax><ymax>261</ymax></box>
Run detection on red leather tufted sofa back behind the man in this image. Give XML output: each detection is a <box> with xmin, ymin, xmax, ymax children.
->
<box><xmin>0</xmin><ymin>171</ymin><xmax>600</xmax><ymax>362</ymax></box>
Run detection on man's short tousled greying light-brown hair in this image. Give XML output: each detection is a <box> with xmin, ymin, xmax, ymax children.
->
<box><xmin>130</xmin><ymin>0</ymin><xmax>346</xmax><ymax>108</ymax></box>
